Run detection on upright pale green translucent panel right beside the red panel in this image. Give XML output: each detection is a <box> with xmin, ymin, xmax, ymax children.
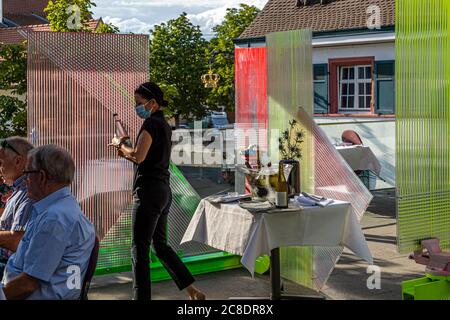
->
<box><xmin>267</xmin><ymin>30</ymin><xmax>314</xmax><ymax>288</ymax></box>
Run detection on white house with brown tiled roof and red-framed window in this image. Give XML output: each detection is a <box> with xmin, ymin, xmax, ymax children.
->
<box><xmin>235</xmin><ymin>0</ymin><xmax>395</xmax><ymax>189</ymax></box>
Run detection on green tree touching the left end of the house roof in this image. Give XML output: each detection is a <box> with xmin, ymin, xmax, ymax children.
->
<box><xmin>207</xmin><ymin>4</ymin><xmax>260</xmax><ymax>111</ymax></box>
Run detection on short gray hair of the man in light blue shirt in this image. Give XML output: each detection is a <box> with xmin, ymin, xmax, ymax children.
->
<box><xmin>28</xmin><ymin>144</ymin><xmax>75</xmax><ymax>186</ymax></box>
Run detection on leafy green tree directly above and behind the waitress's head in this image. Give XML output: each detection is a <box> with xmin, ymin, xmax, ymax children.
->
<box><xmin>150</xmin><ymin>13</ymin><xmax>208</xmax><ymax>125</ymax></box>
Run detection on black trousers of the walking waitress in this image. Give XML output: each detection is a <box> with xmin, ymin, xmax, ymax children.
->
<box><xmin>131</xmin><ymin>182</ymin><xmax>195</xmax><ymax>300</ymax></box>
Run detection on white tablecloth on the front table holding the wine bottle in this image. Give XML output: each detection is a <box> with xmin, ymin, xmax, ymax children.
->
<box><xmin>181</xmin><ymin>200</ymin><xmax>373</xmax><ymax>275</ymax></box>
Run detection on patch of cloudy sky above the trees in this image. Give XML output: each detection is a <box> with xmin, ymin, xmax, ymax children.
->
<box><xmin>93</xmin><ymin>0</ymin><xmax>268</xmax><ymax>37</ymax></box>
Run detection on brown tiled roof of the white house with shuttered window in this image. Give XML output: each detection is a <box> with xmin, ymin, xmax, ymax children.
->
<box><xmin>239</xmin><ymin>0</ymin><xmax>395</xmax><ymax>39</ymax></box>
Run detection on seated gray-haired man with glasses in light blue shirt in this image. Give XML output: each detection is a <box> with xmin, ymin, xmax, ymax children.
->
<box><xmin>0</xmin><ymin>145</ymin><xmax>95</xmax><ymax>300</ymax></box>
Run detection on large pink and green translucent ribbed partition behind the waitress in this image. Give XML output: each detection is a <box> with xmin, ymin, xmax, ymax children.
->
<box><xmin>27</xmin><ymin>32</ymin><xmax>220</xmax><ymax>273</ymax></box>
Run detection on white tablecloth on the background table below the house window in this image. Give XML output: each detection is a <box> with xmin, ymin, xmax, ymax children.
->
<box><xmin>336</xmin><ymin>146</ymin><xmax>381</xmax><ymax>175</ymax></box>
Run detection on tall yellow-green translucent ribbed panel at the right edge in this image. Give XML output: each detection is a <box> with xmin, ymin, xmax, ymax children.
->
<box><xmin>396</xmin><ymin>0</ymin><xmax>450</xmax><ymax>253</ymax></box>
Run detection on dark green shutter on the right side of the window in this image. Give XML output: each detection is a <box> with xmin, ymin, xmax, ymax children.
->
<box><xmin>375</xmin><ymin>61</ymin><xmax>395</xmax><ymax>114</ymax></box>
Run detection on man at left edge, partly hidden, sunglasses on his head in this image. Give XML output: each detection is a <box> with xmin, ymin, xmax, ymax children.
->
<box><xmin>0</xmin><ymin>137</ymin><xmax>33</xmax><ymax>277</ymax></box>
